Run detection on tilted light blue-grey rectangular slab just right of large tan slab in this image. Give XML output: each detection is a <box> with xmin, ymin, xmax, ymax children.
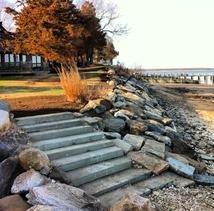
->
<box><xmin>166</xmin><ymin>158</ymin><xmax>195</xmax><ymax>179</ymax></box>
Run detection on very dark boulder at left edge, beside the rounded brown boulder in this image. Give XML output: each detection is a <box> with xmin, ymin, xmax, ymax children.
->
<box><xmin>0</xmin><ymin>157</ymin><xmax>23</xmax><ymax>198</ymax></box>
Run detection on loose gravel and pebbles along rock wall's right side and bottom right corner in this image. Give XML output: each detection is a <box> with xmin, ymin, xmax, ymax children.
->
<box><xmin>147</xmin><ymin>86</ymin><xmax>214</xmax><ymax>211</ymax></box>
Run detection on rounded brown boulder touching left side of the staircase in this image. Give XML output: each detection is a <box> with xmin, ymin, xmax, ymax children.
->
<box><xmin>18</xmin><ymin>148</ymin><xmax>50</xmax><ymax>174</ymax></box>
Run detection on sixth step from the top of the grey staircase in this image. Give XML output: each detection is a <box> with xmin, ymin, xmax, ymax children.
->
<box><xmin>53</xmin><ymin>146</ymin><xmax>123</xmax><ymax>171</ymax></box>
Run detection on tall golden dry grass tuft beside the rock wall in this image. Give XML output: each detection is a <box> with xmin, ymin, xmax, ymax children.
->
<box><xmin>59</xmin><ymin>67</ymin><xmax>110</xmax><ymax>103</ymax></box>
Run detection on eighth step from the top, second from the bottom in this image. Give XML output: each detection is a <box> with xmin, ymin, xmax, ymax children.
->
<box><xmin>80</xmin><ymin>169</ymin><xmax>152</xmax><ymax>197</ymax></box>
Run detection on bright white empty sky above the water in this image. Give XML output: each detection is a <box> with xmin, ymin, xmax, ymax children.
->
<box><xmin>5</xmin><ymin>0</ymin><xmax>214</xmax><ymax>68</ymax></box>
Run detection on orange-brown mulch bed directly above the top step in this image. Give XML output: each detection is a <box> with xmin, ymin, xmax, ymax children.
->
<box><xmin>5</xmin><ymin>95</ymin><xmax>84</xmax><ymax>117</ymax></box>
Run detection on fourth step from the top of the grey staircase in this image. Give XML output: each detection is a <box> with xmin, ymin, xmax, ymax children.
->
<box><xmin>33</xmin><ymin>132</ymin><xmax>104</xmax><ymax>151</ymax></box>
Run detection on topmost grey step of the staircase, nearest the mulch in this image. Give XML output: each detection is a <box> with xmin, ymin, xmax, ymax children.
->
<box><xmin>16</xmin><ymin>112</ymin><xmax>74</xmax><ymax>126</ymax></box>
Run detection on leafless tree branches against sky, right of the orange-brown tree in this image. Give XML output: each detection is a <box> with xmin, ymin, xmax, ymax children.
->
<box><xmin>75</xmin><ymin>0</ymin><xmax>128</xmax><ymax>36</ymax></box>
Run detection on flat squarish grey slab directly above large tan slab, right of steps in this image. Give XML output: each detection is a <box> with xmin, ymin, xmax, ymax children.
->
<box><xmin>141</xmin><ymin>139</ymin><xmax>166</xmax><ymax>159</ymax></box>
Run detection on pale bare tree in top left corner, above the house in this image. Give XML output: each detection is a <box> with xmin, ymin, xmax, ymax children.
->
<box><xmin>0</xmin><ymin>0</ymin><xmax>15</xmax><ymax>31</ymax></box>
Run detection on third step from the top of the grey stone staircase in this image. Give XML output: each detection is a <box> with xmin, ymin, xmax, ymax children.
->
<box><xmin>29</xmin><ymin>126</ymin><xmax>94</xmax><ymax>141</ymax></box>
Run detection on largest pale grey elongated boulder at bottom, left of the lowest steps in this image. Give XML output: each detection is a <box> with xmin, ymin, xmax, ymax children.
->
<box><xmin>26</xmin><ymin>183</ymin><xmax>101</xmax><ymax>210</ymax></box>
